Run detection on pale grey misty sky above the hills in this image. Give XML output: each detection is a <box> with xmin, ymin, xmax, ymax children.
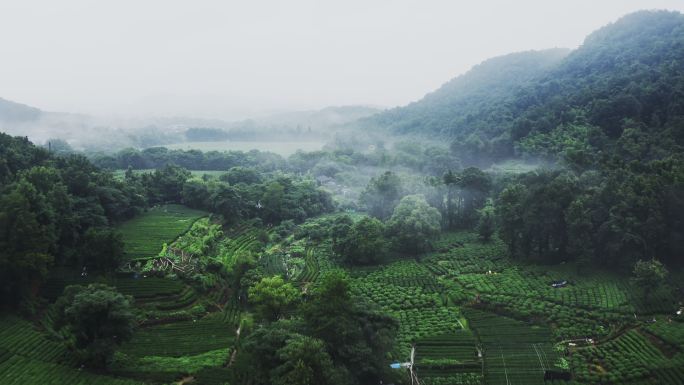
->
<box><xmin>0</xmin><ymin>0</ymin><xmax>684</xmax><ymax>119</ymax></box>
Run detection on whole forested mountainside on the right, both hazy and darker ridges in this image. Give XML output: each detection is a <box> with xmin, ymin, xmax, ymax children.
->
<box><xmin>360</xmin><ymin>11</ymin><xmax>684</xmax><ymax>164</ymax></box>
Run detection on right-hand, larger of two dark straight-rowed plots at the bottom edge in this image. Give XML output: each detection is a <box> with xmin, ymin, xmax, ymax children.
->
<box><xmin>465</xmin><ymin>309</ymin><xmax>563</xmax><ymax>385</ymax></box>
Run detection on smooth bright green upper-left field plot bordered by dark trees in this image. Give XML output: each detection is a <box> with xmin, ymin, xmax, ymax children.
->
<box><xmin>118</xmin><ymin>205</ymin><xmax>207</xmax><ymax>260</ymax></box>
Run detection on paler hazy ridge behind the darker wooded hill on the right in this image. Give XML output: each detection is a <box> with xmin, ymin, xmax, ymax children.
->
<box><xmin>369</xmin><ymin>49</ymin><xmax>568</xmax><ymax>164</ymax></box>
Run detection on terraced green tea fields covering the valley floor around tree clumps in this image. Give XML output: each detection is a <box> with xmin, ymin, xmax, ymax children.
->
<box><xmin>0</xmin><ymin>210</ymin><xmax>684</xmax><ymax>385</ymax></box>
